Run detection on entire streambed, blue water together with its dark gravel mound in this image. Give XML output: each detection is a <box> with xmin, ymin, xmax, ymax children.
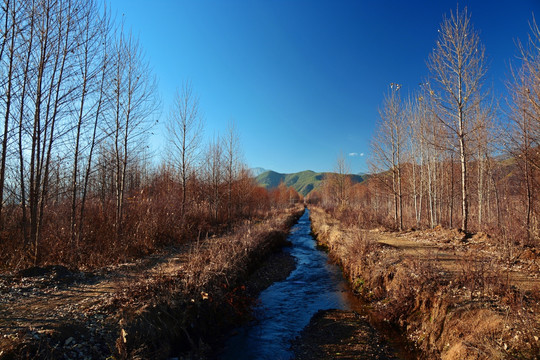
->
<box><xmin>217</xmin><ymin>210</ymin><xmax>398</xmax><ymax>359</ymax></box>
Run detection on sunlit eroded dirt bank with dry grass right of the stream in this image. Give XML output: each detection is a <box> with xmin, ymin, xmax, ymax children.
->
<box><xmin>311</xmin><ymin>209</ymin><xmax>540</xmax><ymax>359</ymax></box>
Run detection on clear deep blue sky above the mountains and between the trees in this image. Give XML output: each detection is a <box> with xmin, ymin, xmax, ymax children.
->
<box><xmin>110</xmin><ymin>0</ymin><xmax>540</xmax><ymax>173</ymax></box>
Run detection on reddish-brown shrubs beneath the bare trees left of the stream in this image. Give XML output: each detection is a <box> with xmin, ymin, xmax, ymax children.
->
<box><xmin>0</xmin><ymin>163</ymin><xmax>300</xmax><ymax>270</ymax></box>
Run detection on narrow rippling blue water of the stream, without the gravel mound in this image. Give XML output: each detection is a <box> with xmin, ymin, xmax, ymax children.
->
<box><xmin>220</xmin><ymin>209</ymin><xmax>353</xmax><ymax>359</ymax></box>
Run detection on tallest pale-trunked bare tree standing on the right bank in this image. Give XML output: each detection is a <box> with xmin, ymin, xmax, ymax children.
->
<box><xmin>428</xmin><ymin>8</ymin><xmax>486</xmax><ymax>231</ymax></box>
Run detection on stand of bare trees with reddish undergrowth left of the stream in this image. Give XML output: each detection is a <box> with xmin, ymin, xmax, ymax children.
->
<box><xmin>0</xmin><ymin>0</ymin><xmax>300</xmax><ymax>268</ymax></box>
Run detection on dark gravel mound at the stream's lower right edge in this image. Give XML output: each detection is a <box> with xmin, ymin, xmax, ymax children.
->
<box><xmin>293</xmin><ymin>310</ymin><xmax>398</xmax><ymax>360</ymax></box>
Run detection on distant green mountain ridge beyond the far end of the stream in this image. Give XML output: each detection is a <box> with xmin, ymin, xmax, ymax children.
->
<box><xmin>255</xmin><ymin>170</ymin><xmax>364</xmax><ymax>196</ymax></box>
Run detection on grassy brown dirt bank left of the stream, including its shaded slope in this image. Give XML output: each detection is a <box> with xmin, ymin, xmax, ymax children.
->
<box><xmin>0</xmin><ymin>208</ymin><xmax>303</xmax><ymax>359</ymax></box>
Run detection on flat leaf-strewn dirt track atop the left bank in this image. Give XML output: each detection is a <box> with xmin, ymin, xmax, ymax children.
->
<box><xmin>0</xmin><ymin>246</ymin><xmax>193</xmax><ymax>359</ymax></box>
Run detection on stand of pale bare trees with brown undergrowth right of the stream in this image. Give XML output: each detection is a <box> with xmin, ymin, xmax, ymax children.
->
<box><xmin>316</xmin><ymin>9</ymin><xmax>540</xmax><ymax>246</ymax></box>
